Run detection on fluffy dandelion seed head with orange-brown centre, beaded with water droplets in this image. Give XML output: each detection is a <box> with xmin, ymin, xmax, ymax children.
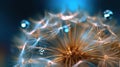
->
<box><xmin>16</xmin><ymin>10</ymin><xmax>120</xmax><ymax>67</ymax></box>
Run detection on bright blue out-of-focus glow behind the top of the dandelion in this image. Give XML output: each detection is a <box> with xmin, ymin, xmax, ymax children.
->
<box><xmin>39</xmin><ymin>0</ymin><xmax>95</xmax><ymax>12</ymax></box>
